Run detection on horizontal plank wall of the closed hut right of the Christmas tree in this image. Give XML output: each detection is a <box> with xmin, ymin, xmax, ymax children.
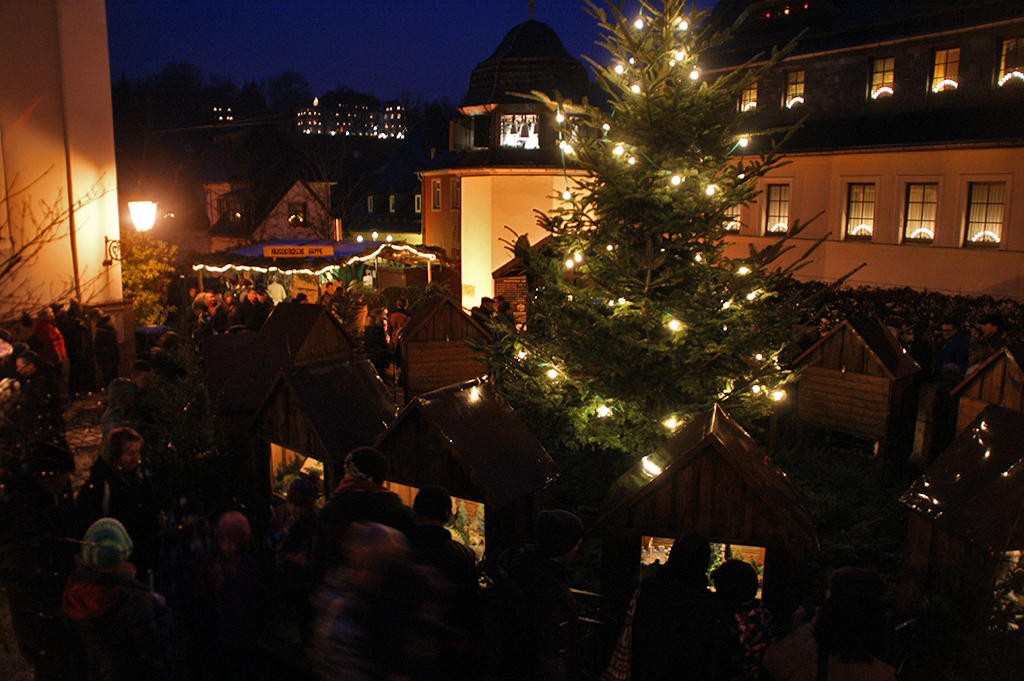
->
<box><xmin>797</xmin><ymin>367</ymin><xmax>892</xmax><ymax>439</ymax></box>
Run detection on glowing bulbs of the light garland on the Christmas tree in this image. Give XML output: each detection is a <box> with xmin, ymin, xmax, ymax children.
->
<box><xmin>528</xmin><ymin>5</ymin><xmax>786</xmax><ymax>430</ymax></box>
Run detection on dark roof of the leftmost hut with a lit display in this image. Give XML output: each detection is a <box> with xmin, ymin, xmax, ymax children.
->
<box><xmin>257</xmin><ymin>359</ymin><xmax>398</xmax><ymax>456</ymax></box>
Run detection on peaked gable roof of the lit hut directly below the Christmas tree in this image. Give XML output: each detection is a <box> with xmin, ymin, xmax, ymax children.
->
<box><xmin>597</xmin><ymin>405</ymin><xmax>818</xmax><ymax>549</ymax></box>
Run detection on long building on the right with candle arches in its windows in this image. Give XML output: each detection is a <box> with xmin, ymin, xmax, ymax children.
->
<box><xmin>703</xmin><ymin>0</ymin><xmax>1024</xmax><ymax>296</ymax></box>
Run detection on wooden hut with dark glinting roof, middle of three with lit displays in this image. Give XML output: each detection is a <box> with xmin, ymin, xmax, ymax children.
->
<box><xmin>377</xmin><ymin>379</ymin><xmax>559</xmax><ymax>557</ymax></box>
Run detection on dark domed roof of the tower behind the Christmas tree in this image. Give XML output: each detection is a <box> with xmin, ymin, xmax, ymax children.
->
<box><xmin>462</xmin><ymin>18</ymin><xmax>590</xmax><ymax>108</ymax></box>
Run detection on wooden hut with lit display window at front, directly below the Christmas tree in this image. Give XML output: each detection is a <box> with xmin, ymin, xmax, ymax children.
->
<box><xmin>596</xmin><ymin>405</ymin><xmax>818</xmax><ymax>613</ymax></box>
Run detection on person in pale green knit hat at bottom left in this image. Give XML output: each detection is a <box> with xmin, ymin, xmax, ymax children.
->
<box><xmin>61</xmin><ymin>518</ymin><xmax>170</xmax><ymax>681</ymax></box>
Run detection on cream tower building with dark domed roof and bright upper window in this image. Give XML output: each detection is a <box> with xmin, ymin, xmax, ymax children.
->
<box><xmin>420</xmin><ymin>17</ymin><xmax>591</xmax><ymax>307</ymax></box>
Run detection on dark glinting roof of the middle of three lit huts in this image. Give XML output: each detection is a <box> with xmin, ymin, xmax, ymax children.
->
<box><xmin>377</xmin><ymin>379</ymin><xmax>559</xmax><ymax>509</ymax></box>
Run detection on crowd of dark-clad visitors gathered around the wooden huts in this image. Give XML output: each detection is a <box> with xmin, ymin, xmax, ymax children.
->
<box><xmin>6</xmin><ymin>284</ymin><xmax>1008</xmax><ymax>681</ymax></box>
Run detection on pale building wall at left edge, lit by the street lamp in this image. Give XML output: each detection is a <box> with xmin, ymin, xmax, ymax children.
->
<box><xmin>0</xmin><ymin>0</ymin><xmax>122</xmax><ymax>318</ymax></box>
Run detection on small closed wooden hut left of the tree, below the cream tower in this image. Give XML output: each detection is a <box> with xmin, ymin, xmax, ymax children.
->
<box><xmin>399</xmin><ymin>295</ymin><xmax>490</xmax><ymax>402</ymax></box>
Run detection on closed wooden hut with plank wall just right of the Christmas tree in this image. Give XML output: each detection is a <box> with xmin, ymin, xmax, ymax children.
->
<box><xmin>794</xmin><ymin>314</ymin><xmax>921</xmax><ymax>466</ymax></box>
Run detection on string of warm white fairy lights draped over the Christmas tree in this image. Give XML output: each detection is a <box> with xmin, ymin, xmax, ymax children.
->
<box><xmin>515</xmin><ymin>5</ymin><xmax>786</xmax><ymax>431</ymax></box>
